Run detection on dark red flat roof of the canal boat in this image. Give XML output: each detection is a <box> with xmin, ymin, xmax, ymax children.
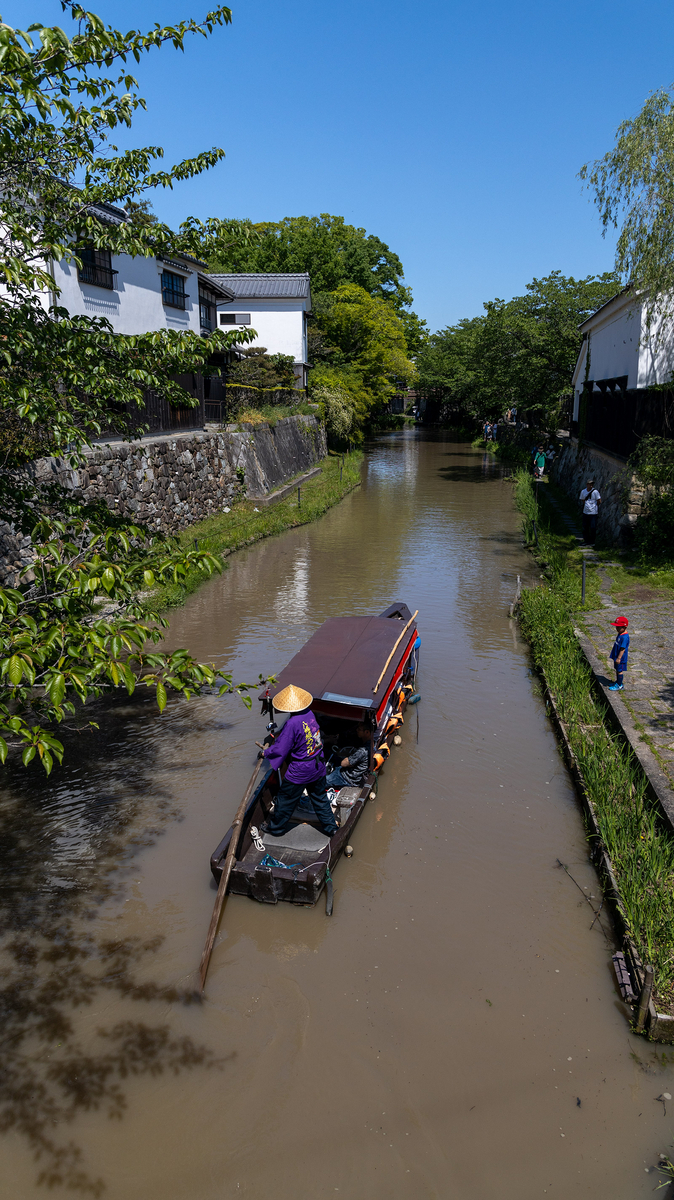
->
<box><xmin>268</xmin><ymin>604</ymin><xmax>416</xmax><ymax>708</ymax></box>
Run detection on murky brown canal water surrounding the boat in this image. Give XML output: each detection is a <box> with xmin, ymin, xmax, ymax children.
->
<box><xmin>0</xmin><ymin>431</ymin><xmax>674</xmax><ymax>1200</ymax></box>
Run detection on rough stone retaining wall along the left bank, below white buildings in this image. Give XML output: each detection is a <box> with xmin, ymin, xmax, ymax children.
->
<box><xmin>0</xmin><ymin>416</ymin><xmax>327</xmax><ymax>587</ymax></box>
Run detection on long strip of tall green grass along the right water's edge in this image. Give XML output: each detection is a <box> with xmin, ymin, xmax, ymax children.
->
<box><xmin>516</xmin><ymin>470</ymin><xmax>674</xmax><ymax>1012</ymax></box>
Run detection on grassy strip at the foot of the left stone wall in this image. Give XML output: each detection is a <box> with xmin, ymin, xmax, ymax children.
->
<box><xmin>152</xmin><ymin>450</ymin><xmax>363</xmax><ymax>608</ymax></box>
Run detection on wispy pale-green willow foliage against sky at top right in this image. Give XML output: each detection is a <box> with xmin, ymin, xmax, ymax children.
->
<box><xmin>580</xmin><ymin>88</ymin><xmax>674</xmax><ymax>314</ymax></box>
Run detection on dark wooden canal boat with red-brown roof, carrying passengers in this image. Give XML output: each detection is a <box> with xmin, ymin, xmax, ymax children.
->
<box><xmin>211</xmin><ymin>604</ymin><xmax>419</xmax><ymax>913</ymax></box>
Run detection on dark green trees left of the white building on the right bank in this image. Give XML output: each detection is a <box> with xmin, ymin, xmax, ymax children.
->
<box><xmin>417</xmin><ymin>271</ymin><xmax>620</xmax><ymax>424</ymax></box>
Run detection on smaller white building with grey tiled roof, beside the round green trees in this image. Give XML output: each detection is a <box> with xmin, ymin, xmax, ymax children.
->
<box><xmin>209</xmin><ymin>272</ymin><xmax>312</xmax><ymax>388</ymax></box>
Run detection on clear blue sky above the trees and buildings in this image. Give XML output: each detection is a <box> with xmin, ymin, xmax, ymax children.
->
<box><xmin>5</xmin><ymin>0</ymin><xmax>674</xmax><ymax>329</ymax></box>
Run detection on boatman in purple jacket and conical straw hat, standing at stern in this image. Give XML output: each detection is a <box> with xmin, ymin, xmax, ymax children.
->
<box><xmin>260</xmin><ymin>684</ymin><xmax>337</xmax><ymax>838</ymax></box>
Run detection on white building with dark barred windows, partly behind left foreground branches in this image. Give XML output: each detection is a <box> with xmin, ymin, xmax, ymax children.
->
<box><xmin>52</xmin><ymin>204</ymin><xmax>233</xmax><ymax>334</ymax></box>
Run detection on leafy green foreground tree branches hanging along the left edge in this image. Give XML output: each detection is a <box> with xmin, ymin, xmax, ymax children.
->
<box><xmin>0</xmin><ymin>0</ymin><xmax>267</xmax><ymax>772</ymax></box>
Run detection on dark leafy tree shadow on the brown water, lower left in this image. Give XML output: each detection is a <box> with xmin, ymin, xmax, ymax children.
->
<box><xmin>0</xmin><ymin>700</ymin><xmax>225</xmax><ymax>1196</ymax></box>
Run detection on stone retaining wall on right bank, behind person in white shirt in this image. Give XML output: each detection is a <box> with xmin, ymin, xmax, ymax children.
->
<box><xmin>550</xmin><ymin>439</ymin><xmax>650</xmax><ymax>546</ymax></box>
